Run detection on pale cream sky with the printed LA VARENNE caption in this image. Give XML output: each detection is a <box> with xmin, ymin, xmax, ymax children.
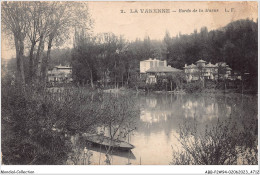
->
<box><xmin>1</xmin><ymin>1</ymin><xmax>258</xmax><ymax>59</ymax></box>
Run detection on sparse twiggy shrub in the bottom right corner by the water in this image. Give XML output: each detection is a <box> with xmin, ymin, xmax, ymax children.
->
<box><xmin>171</xmin><ymin>117</ymin><xmax>258</xmax><ymax>165</ymax></box>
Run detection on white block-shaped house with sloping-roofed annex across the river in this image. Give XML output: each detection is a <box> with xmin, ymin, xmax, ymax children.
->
<box><xmin>140</xmin><ymin>58</ymin><xmax>182</xmax><ymax>84</ymax></box>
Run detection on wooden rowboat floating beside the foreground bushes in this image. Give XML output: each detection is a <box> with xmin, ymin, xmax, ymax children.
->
<box><xmin>86</xmin><ymin>135</ymin><xmax>135</xmax><ymax>150</ymax></box>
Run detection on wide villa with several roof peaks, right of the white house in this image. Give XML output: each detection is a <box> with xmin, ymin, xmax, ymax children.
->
<box><xmin>183</xmin><ymin>60</ymin><xmax>232</xmax><ymax>82</ymax></box>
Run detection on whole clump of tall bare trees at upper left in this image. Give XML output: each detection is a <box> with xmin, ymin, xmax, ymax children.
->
<box><xmin>2</xmin><ymin>2</ymin><xmax>92</xmax><ymax>86</ymax></box>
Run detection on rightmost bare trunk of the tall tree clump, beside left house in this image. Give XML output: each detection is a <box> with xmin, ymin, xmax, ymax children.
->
<box><xmin>42</xmin><ymin>35</ymin><xmax>53</xmax><ymax>87</ymax></box>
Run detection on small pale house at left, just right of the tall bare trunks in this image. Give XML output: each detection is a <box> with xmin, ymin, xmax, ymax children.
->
<box><xmin>48</xmin><ymin>65</ymin><xmax>72</xmax><ymax>83</ymax></box>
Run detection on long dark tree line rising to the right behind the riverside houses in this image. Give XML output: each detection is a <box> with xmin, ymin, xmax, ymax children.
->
<box><xmin>71</xmin><ymin>19</ymin><xmax>258</xmax><ymax>87</ymax></box>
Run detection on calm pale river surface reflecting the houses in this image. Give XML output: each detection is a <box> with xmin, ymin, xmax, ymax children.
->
<box><xmin>68</xmin><ymin>94</ymin><xmax>257</xmax><ymax>165</ymax></box>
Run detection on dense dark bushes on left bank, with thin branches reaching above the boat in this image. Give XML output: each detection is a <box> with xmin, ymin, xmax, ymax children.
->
<box><xmin>1</xmin><ymin>80</ymin><xmax>140</xmax><ymax>165</ymax></box>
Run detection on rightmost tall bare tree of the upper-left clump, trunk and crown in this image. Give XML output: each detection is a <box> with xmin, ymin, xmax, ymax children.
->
<box><xmin>42</xmin><ymin>2</ymin><xmax>92</xmax><ymax>86</ymax></box>
